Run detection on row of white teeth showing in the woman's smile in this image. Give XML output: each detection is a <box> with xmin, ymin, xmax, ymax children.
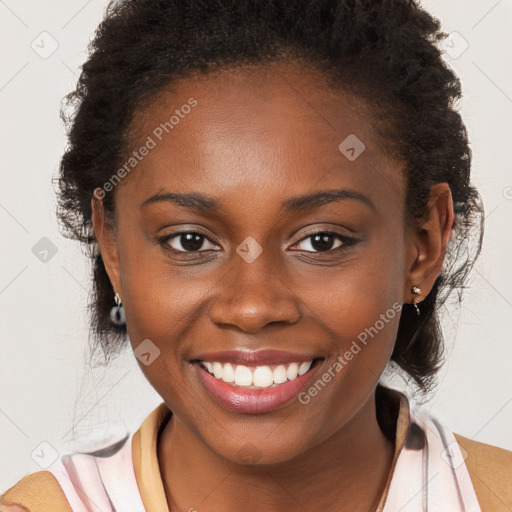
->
<box><xmin>203</xmin><ymin>360</ymin><xmax>313</xmax><ymax>388</ymax></box>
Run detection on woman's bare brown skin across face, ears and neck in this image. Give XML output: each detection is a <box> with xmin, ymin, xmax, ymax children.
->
<box><xmin>92</xmin><ymin>64</ymin><xmax>453</xmax><ymax>512</ymax></box>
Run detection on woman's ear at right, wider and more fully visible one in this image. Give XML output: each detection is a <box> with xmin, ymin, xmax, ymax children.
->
<box><xmin>404</xmin><ymin>183</ymin><xmax>455</xmax><ymax>303</ymax></box>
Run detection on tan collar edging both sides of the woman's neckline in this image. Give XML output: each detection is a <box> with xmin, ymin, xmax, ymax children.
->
<box><xmin>132</xmin><ymin>391</ymin><xmax>410</xmax><ymax>512</ymax></box>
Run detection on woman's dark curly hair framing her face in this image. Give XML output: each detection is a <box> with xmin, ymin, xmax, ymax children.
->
<box><xmin>57</xmin><ymin>0</ymin><xmax>484</xmax><ymax>392</ymax></box>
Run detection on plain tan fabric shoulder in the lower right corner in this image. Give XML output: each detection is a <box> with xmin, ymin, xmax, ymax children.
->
<box><xmin>453</xmin><ymin>433</ymin><xmax>512</xmax><ymax>512</ymax></box>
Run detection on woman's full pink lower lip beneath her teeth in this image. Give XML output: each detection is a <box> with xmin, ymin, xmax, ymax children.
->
<box><xmin>194</xmin><ymin>361</ymin><xmax>321</xmax><ymax>414</ymax></box>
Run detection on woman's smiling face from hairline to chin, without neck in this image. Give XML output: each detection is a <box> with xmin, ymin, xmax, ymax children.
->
<box><xmin>96</xmin><ymin>65</ymin><xmax>432</xmax><ymax>462</ymax></box>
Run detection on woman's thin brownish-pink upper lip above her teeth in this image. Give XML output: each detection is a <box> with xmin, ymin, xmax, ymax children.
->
<box><xmin>192</xmin><ymin>350</ymin><xmax>321</xmax><ymax>365</ymax></box>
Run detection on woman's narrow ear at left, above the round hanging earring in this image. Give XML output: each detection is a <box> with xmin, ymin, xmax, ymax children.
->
<box><xmin>91</xmin><ymin>197</ymin><xmax>123</xmax><ymax>299</ymax></box>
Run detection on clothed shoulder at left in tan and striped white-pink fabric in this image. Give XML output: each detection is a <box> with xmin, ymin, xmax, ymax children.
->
<box><xmin>0</xmin><ymin>402</ymin><xmax>171</xmax><ymax>512</ymax></box>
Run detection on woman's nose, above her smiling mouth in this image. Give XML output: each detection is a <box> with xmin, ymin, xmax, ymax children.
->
<box><xmin>210</xmin><ymin>256</ymin><xmax>301</xmax><ymax>333</ymax></box>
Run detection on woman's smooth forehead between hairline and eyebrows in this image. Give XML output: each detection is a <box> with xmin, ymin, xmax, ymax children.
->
<box><xmin>118</xmin><ymin>64</ymin><xmax>404</xmax><ymax>216</ymax></box>
